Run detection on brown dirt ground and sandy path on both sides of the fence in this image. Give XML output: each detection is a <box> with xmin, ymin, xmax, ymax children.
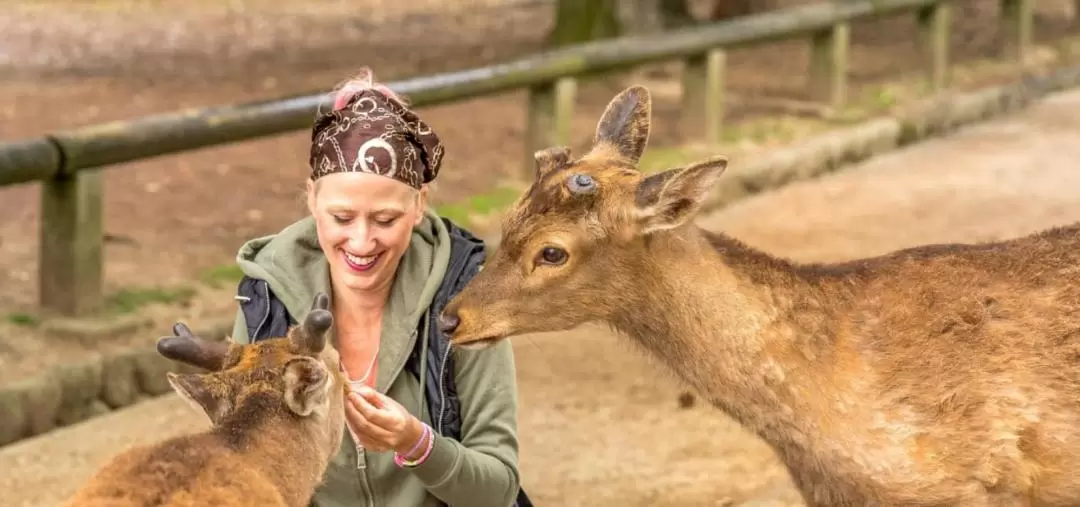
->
<box><xmin>0</xmin><ymin>0</ymin><xmax>1080</xmax><ymax>507</ymax></box>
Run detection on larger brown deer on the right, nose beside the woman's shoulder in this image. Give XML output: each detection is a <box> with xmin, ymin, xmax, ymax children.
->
<box><xmin>440</xmin><ymin>86</ymin><xmax>1080</xmax><ymax>506</ymax></box>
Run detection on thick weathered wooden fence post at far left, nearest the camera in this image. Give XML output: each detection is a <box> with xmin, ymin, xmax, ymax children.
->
<box><xmin>38</xmin><ymin>171</ymin><xmax>104</xmax><ymax>317</ymax></box>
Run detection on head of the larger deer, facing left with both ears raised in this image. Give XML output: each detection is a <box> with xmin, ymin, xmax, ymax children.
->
<box><xmin>440</xmin><ymin>86</ymin><xmax>727</xmax><ymax>347</ymax></box>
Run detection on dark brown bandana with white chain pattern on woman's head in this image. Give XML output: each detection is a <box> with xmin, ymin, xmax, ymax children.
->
<box><xmin>309</xmin><ymin>89</ymin><xmax>443</xmax><ymax>188</ymax></box>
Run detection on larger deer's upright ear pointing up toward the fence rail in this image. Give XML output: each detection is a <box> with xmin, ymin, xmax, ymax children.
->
<box><xmin>593</xmin><ymin>85</ymin><xmax>652</xmax><ymax>164</ymax></box>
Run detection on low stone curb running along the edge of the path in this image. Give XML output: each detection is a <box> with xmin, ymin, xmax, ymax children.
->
<box><xmin>0</xmin><ymin>62</ymin><xmax>1080</xmax><ymax>445</ymax></box>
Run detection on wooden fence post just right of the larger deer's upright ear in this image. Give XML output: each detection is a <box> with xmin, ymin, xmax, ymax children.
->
<box><xmin>681</xmin><ymin>50</ymin><xmax>727</xmax><ymax>145</ymax></box>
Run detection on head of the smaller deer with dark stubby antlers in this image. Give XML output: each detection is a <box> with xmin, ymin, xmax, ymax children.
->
<box><xmin>158</xmin><ymin>293</ymin><xmax>346</xmax><ymax>452</ymax></box>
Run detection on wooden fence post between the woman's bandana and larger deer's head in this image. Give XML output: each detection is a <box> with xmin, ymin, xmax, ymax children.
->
<box><xmin>523</xmin><ymin>78</ymin><xmax>578</xmax><ymax>181</ymax></box>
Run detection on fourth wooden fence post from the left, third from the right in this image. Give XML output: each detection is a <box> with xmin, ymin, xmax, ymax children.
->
<box><xmin>810</xmin><ymin>23</ymin><xmax>851</xmax><ymax>107</ymax></box>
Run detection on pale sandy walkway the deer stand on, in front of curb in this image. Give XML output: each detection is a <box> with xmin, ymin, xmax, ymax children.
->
<box><xmin>6</xmin><ymin>91</ymin><xmax>1080</xmax><ymax>507</ymax></box>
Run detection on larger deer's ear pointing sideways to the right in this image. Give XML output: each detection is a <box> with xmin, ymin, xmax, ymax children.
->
<box><xmin>635</xmin><ymin>157</ymin><xmax>728</xmax><ymax>235</ymax></box>
